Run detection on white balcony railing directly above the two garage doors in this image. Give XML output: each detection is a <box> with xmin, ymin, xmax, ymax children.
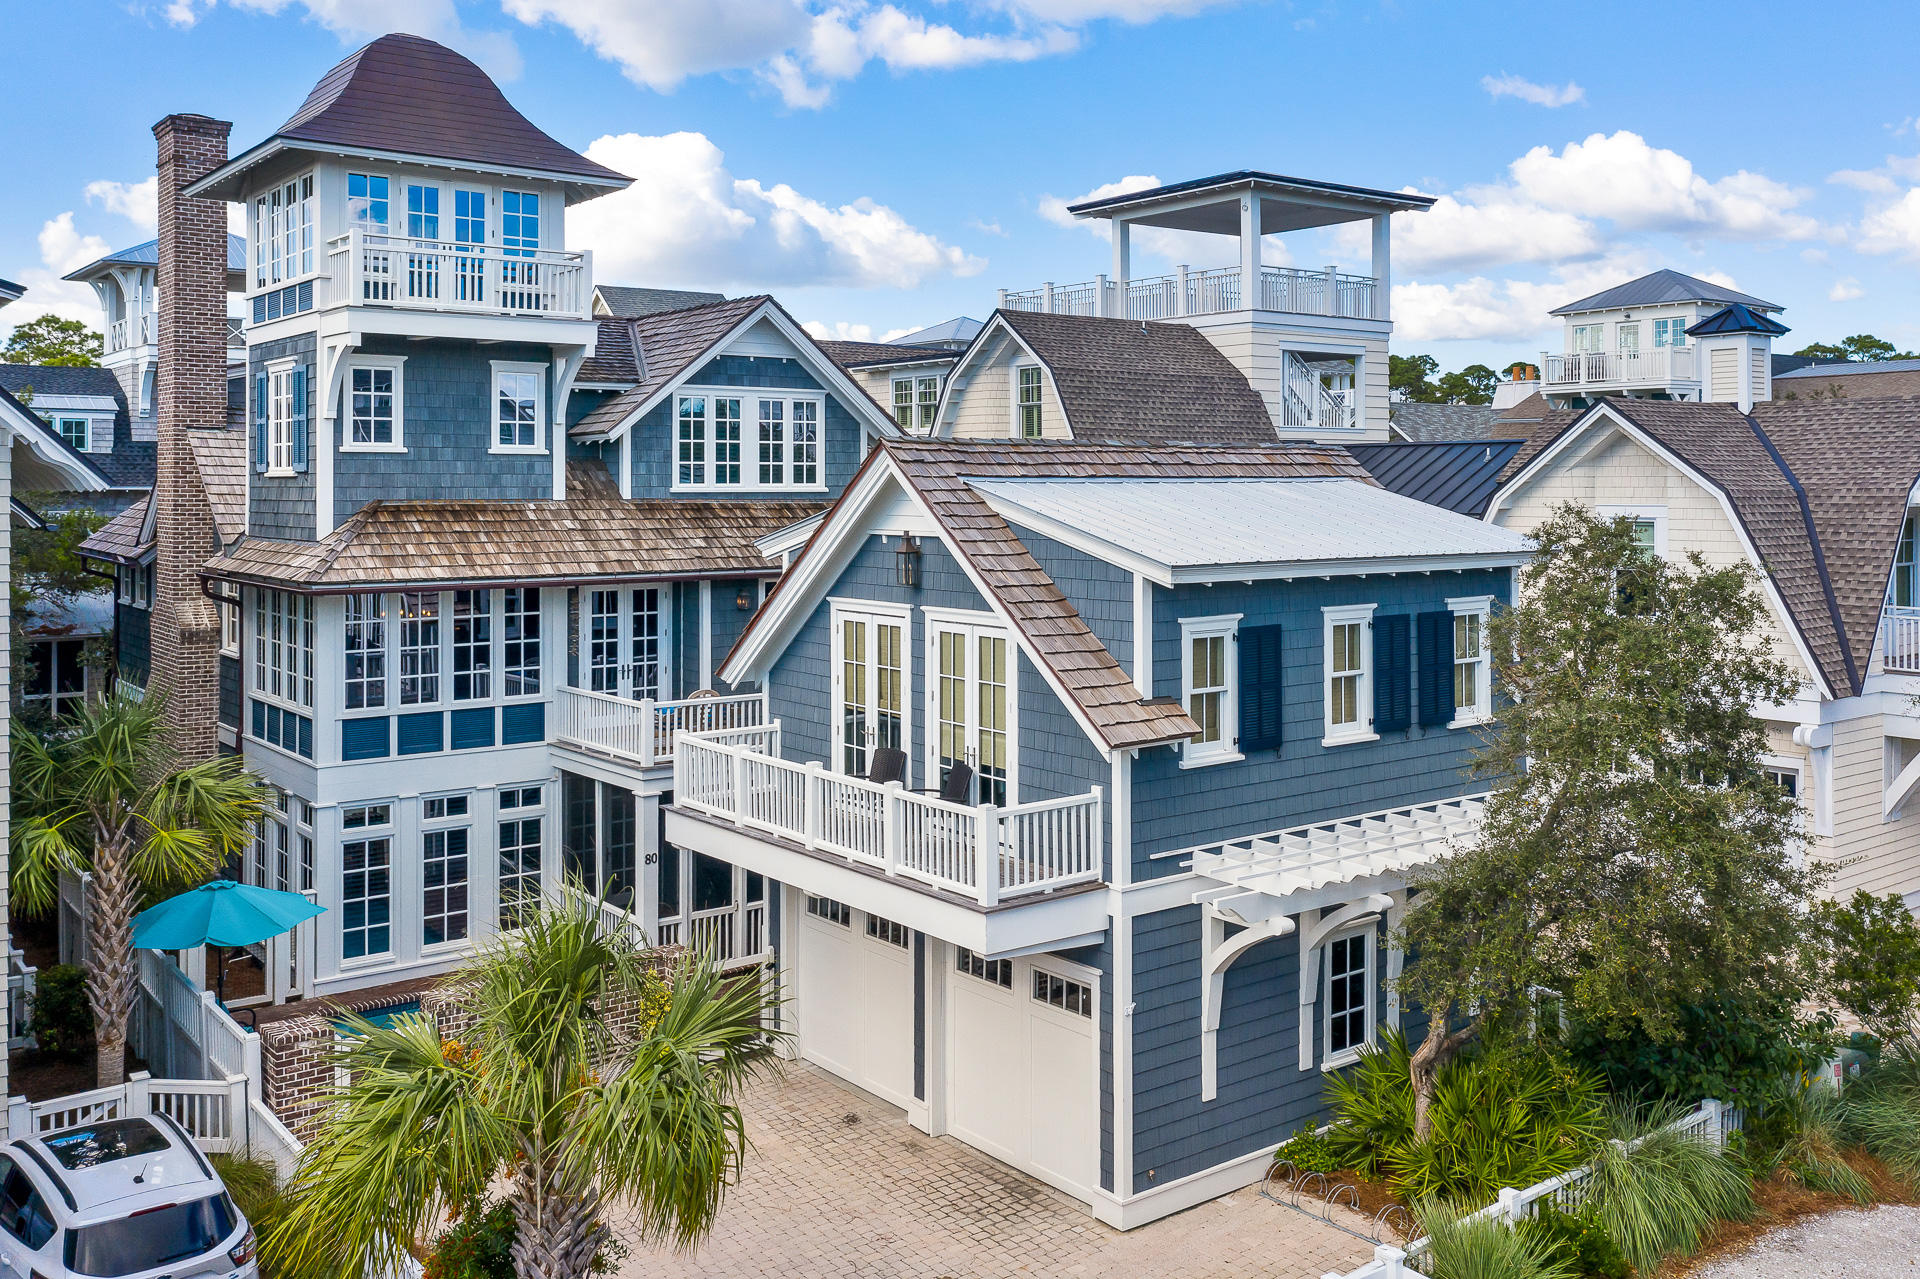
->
<box><xmin>674</xmin><ymin>720</ymin><xmax>1102</xmax><ymax>906</ymax></box>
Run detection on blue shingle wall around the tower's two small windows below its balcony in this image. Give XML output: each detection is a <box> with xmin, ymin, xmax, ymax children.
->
<box><xmin>334</xmin><ymin>338</ymin><xmax>553</xmax><ymax>524</ymax></box>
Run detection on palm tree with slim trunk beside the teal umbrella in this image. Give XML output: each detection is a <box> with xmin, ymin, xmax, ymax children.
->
<box><xmin>12</xmin><ymin>693</ymin><xmax>265</xmax><ymax>1087</ymax></box>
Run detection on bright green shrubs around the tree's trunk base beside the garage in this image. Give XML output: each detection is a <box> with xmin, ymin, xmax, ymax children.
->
<box><xmin>1327</xmin><ymin>1031</ymin><xmax>1605</xmax><ymax>1204</ymax></box>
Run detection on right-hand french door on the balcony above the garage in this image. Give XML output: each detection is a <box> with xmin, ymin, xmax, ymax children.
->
<box><xmin>927</xmin><ymin>618</ymin><xmax>1016</xmax><ymax>805</ymax></box>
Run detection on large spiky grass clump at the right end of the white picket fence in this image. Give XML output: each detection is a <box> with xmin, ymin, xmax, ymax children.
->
<box><xmin>1586</xmin><ymin>1106</ymin><xmax>1753</xmax><ymax>1273</ymax></box>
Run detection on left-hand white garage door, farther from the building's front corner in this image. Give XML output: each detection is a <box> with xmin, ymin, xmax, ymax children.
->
<box><xmin>793</xmin><ymin>897</ymin><xmax>914</xmax><ymax>1108</ymax></box>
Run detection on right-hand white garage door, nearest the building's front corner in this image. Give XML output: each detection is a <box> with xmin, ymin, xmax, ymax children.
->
<box><xmin>947</xmin><ymin>949</ymin><xmax>1100</xmax><ymax>1198</ymax></box>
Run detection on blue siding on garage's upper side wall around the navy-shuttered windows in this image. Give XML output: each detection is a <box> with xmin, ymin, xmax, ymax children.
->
<box><xmin>1133</xmin><ymin>568</ymin><xmax>1509</xmax><ymax>880</ymax></box>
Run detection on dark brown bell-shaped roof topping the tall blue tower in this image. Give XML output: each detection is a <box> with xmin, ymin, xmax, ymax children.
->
<box><xmin>275</xmin><ymin>35</ymin><xmax>632</xmax><ymax>186</ymax></box>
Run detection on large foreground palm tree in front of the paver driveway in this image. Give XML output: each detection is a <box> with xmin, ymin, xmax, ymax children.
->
<box><xmin>263</xmin><ymin>895</ymin><xmax>774</xmax><ymax>1279</ymax></box>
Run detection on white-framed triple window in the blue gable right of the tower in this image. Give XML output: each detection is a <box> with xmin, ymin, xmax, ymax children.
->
<box><xmin>674</xmin><ymin>392</ymin><xmax>824</xmax><ymax>490</ymax></box>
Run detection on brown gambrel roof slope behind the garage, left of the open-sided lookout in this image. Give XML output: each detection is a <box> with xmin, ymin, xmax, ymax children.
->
<box><xmin>975</xmin><ymin>311</ymin><xmax>1279</xmax><ymax>444</ymax></box>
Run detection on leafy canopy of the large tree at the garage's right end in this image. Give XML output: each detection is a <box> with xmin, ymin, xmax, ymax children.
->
<box><xmin>1400</xmin><ymin>505</ymin><xmax>1816</xmax><ymax>1129</ymax></box>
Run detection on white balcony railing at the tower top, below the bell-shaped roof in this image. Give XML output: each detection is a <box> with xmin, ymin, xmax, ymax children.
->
<box><xmin>326</xmin><ymin>229</ymin><xmax>593</xmax><ymax>319</ymax></box>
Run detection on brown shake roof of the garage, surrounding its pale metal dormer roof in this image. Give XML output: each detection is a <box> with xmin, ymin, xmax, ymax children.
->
<box><xmin>741</xmin><ymin>440</ymin><xmax>1373</xmax><ymax>749</ymax></box>
